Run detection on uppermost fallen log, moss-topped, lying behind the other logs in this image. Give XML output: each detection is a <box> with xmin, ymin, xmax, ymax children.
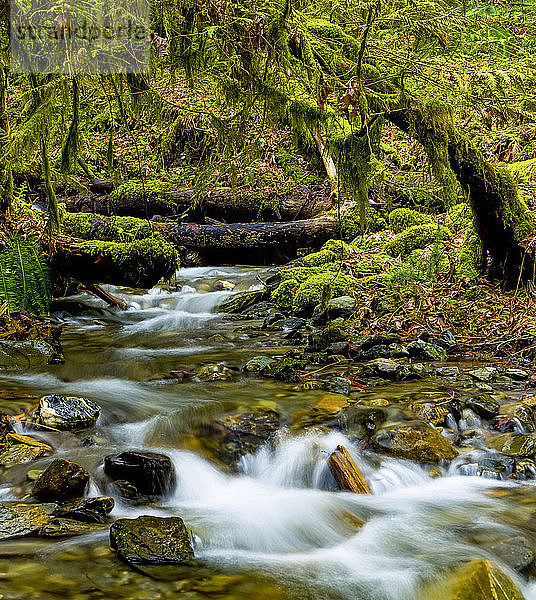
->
<box><xmin>59</xmin><ymin>182</ymin><xmax>333</xmax><ymax>222</ymax></box>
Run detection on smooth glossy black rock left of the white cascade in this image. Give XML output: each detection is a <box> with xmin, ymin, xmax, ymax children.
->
<box><xmin>104</xmin><ymin>450</ymin><xmax>176</xmax><ymax>496</ymax></box>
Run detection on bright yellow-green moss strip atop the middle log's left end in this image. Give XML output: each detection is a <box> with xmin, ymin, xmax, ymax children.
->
<box><xmin>63</xmin><ymin>212</ymin><xmax>154</xmax><ymax>242</ymax></box>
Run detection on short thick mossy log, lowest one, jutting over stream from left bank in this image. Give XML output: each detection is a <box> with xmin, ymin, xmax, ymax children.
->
<box><xmin>49</xmin><ymin>237</ymin><xmax>179</xmax><ymax>288</ymax></box>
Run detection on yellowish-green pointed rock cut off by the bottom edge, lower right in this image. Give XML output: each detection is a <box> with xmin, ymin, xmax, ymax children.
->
<box><xmin>420</xmin><ymin>558</ymin><xmax>525</xmax><ymax>600</ymax></box>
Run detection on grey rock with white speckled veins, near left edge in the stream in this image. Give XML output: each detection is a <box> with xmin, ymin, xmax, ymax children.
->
<box><xmin>34</xmin><ymin>394</ymin><xmax>100</xmax><ymax>431</ymax></box>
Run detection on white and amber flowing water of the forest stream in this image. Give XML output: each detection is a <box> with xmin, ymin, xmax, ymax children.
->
<box><xmin>0</xmin><ymin>268</ymin><xmax>536</xmax><ymax>600</ymax></box>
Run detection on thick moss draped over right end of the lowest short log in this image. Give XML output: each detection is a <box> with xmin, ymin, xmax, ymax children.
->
<box><xmin>78</xmin><ymin>237</ymin><xmax>179</xmax><ymax>287</ymax></box>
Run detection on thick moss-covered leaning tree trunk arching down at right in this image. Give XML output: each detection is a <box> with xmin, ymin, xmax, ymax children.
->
<box><xmin>386</xmin><ymin>102</ymin><xmax>535</xmax><ymax>287</ymax></box>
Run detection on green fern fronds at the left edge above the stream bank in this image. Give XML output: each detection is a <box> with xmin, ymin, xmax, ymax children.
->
<box><xmin>0</xmin><ymin>236</ymin><xmax>50</xmax><ymax>315</ymax></box>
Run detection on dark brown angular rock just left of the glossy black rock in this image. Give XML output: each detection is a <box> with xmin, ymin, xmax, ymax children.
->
<box><xmin>32</xmin><ymin>458</ymin><xmax>89</xmax><ymax>502</ymax></box>
